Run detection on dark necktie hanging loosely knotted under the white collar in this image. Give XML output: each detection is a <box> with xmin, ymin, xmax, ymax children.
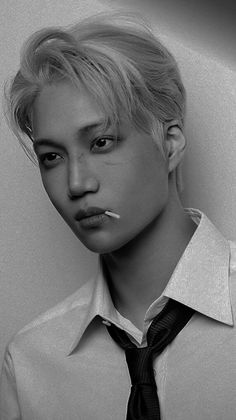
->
<box><xmin>107</xmin><ymin>299</ymin><xmax>194</xmax><ymax>420</ymax></box>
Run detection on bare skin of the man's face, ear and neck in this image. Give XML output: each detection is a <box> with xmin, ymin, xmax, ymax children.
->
<box><xmin>32</xmin><ymin>82</ymin><xmax>195</xmax><ymax>328</ymax></box>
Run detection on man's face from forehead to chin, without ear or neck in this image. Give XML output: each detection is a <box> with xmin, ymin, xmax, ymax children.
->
<box><xmin>32</xmin><ymin>83</ymin><xmax>168</xmax><ymax>254</ymax></box>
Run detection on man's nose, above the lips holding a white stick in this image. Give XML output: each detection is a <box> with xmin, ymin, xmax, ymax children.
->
<box><xmin>68</xmin><ymin>160</ymin><xmax>99</xmax><ymax>198</ymax></box>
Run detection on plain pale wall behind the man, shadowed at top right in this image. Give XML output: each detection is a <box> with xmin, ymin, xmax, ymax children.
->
<box><xmin>0</xmin><ymin>0</ymin><xmax>236</xmax><ymax>362</ymax></box>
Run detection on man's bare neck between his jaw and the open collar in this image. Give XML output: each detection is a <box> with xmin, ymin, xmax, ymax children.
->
<box><xmin>102</xmin><ymin>199</ymin><xmax>196</xmax><ymax>329</ymax></box>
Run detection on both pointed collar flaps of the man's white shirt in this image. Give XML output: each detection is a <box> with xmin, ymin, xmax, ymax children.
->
<box><xmin>67</xmin><ymin>208</ymin><xmax>233</xmax><ymax>355</ymax></box>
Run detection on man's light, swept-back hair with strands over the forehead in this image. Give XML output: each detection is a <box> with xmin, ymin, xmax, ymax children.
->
<box><xmin>5</xmin><ymin>12</ymin><xmax>186</xmax><ymax>190</ymax></box>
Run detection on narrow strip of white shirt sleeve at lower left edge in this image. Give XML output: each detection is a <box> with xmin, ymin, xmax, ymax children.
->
<box><xmin>0</xmin><ymin>349</ymin><xmax>22</xmax><ymax>420</ymax></box>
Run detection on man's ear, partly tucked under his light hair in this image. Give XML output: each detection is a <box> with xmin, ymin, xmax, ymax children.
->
<box><xmin>164</xmin><ymin>120</ymin><xmax>186</xmax><ymax>172</ymax></box>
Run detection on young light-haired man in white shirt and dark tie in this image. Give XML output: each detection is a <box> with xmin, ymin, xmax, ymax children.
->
<box><xmin>1</xmin><ymin>11</ymin><xmax>236</xmax><ymax>420</ymax></box>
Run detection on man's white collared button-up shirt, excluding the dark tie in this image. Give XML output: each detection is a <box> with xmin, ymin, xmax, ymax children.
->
<box><xmin>0</xmin><ymin>209</ymin><xmax>236</xmax><ymax>420</ymax></box>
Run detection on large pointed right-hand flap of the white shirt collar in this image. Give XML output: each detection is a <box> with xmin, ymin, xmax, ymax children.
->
<box><xmin>163</xmin><ymin>209</ymin><xmax>233</xmax><ymax>325</ymax></box>
